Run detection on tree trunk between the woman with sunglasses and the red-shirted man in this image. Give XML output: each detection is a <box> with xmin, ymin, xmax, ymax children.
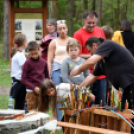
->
<box><xmin>69</xmin><ymin>0</ymin><xmax>75</xmax><ymax>37</ymax></box>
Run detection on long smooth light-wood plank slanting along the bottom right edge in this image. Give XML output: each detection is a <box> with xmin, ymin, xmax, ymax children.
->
<box><xmin>57</xmin><ymin>121</ymin><xmax>130</xmax><ymax>134</ymax></box>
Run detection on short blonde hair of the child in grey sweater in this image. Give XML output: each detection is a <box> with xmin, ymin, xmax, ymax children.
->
<box><xmin>66</xmin><ymin>38</ymin><xmax>81</xmax><ymax>52</ymax></box>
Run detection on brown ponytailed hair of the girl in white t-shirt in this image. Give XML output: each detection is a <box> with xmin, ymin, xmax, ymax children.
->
<box><xmin>11</xmin><ymin>33</ymin><xmax>26</xmax><ymax>58</ymax></box>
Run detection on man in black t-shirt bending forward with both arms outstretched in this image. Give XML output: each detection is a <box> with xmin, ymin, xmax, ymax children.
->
<box><xmin>70</xmin><ymin>37</ymin><xmax>134</xmax><ymax>109</ymax></box>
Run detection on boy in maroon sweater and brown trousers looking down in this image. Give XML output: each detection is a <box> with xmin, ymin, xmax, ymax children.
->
<box><xmin>21</xmin><ymin>41</ymin><xmax>49</xmax><ymax>111</ymax></box>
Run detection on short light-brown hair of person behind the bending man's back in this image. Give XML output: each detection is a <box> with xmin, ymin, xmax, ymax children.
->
<box><xmin>101</xmin><ymin>26</ymin><xmax>114</xmax><ymax>40</ymax></box>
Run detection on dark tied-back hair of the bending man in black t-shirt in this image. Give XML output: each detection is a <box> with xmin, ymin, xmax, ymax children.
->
<box><xmin>86</xmin><ymin>36</ymin><xmax>104</xmax><ymax>47</ymax></box>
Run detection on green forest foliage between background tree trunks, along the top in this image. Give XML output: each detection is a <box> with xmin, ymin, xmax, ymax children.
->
<box><xmin>0</xmin><ymin>0</ymin><xmax>134</xmax><ymax>37</ymax></box>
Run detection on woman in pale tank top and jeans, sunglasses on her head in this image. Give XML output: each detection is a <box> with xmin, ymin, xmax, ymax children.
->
<box><xmin>47</xmin><ymin>20</ymin><xmax>70</xmax><ymax>120</ymax></box>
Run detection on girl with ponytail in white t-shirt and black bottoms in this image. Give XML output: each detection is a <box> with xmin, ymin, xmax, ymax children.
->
<box><xmin>10</xmin><ymin>33</ymin><xmax>27</xmax><ymax>110</ymax></box>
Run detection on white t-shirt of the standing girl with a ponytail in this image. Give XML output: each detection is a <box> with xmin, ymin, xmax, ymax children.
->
<box><xmin>11</xmin><ymin>51</ymin><xmax>26</xmax><ymax>80</ymax></box>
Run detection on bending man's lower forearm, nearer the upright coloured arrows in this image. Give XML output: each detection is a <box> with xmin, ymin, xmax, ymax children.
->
<box><xmin>80</xmin><ymin>74</ymin><xmax>99</xmax><ymax>87</ymax></box>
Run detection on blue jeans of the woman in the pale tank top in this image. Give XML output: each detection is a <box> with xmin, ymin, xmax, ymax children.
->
<box><xmin>51</xmin><ymin>69</ymin><xmax>62</xmax><ymax>121</ymax></box>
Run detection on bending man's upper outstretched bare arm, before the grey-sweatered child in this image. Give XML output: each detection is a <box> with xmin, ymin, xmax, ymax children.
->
<box><xmin>70</xmin><ymin>55</ymin><xmax>104</xmax><ymax>77</ymax></box>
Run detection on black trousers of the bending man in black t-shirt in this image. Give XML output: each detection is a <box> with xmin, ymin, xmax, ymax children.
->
<box><xmin>121</xmin><ymin>83</ymin><xmax>134</xmax><ymax>134</ymax></box>
